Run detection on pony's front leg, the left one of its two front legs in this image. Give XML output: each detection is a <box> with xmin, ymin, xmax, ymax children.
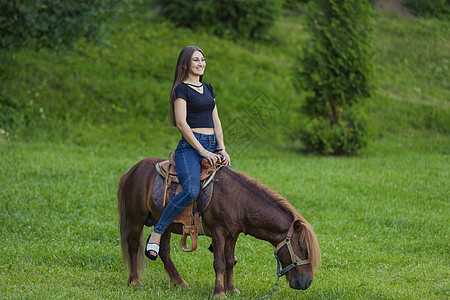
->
<box><xmin>213</xmin><ymin>232</ymin><xmax>226</xmax><ymax>298</ymax></box>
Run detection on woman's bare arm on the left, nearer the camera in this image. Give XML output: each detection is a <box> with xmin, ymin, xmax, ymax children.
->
<box><xmin>174</xmin><ymin>98</ymin><xmax>220</xmax><ymax>165</ymax></box>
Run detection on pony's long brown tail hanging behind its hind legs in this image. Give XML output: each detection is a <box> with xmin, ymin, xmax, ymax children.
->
<box><xmin>117</xmin><ymin>171</ymin><xmax>145</xmax><ymax>275</ymax></box>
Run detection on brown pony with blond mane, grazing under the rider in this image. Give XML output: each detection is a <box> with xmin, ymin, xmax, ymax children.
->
<box><xmin>117</xmin><ymin>157</ymin><xmax>320</xmax><ymax>298</ymax></box>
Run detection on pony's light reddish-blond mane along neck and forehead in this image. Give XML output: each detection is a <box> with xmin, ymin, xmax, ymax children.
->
<box><xmin>223</xmin><ymin>168</ymin><xmax>320</xmax><ymax>269</ymax></box>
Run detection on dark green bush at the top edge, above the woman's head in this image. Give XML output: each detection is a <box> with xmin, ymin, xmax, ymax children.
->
<box><xmin>159</xmin><ymin>0</ymin><xmax>283</xmax><ymax>39</ymax></box>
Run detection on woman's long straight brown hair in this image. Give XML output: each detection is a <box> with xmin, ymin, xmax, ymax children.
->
<box><xmin>169</xmin><ymin>46</ymin><xmax>205</xmax><ymax>126</ymax></box>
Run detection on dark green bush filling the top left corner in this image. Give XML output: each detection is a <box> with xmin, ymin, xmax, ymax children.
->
<box><xmin>0</xmin><ymin>0</ymin><xmax>132</xmax><ymax>49</ymax></box>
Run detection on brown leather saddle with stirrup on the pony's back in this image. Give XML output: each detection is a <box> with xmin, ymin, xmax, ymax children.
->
<box><xmin>156</xmin><ymin>152</ymin><xmax>223</xmax><ymax>252</ymax></box>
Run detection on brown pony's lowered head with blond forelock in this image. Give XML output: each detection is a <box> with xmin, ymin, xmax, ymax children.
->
<box><xmin>277</xmin><ymin>216</ymin><xmax>320</xmax><ymax>290</ymax></box>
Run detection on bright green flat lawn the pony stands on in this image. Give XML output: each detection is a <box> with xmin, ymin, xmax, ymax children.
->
<box><xmin>0</xmin><ymin>142</ymin><xmax>450</xmax><ymax>299</ymax></box>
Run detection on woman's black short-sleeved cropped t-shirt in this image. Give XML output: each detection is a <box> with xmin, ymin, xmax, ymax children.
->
<box><xmin>174</xmin><ymin>82</ymin><xmax>216</xmax><ymax>128</ymax></box>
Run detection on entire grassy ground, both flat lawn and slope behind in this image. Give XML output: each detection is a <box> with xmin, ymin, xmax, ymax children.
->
<box><xmin>0</xmin><ymin>2</ymin><xmax>450</xmax><ymax>299</ymax></box>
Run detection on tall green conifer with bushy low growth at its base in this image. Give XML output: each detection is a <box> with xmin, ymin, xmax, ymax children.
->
<box><xmin>299</xmin><ymin>0</ymin><xmax>372</xmax><ymax>154</ymax></box>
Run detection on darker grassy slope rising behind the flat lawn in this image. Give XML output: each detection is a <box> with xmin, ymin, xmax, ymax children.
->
<box><xmin>1</xmin><ymin>7</ymin><xmax>450</xmax><ymax>155</ymax></box>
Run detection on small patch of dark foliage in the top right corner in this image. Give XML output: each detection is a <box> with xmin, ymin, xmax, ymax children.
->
<box><xmin>405</xmin><ymin>0</ymin><xmax>450</xmax><ymax>20</ymax></box>
